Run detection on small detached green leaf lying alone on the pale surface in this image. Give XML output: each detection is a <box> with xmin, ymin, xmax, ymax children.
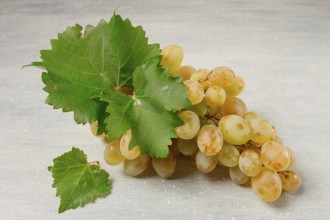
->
<box><xmin>48</xmin><ymin>147</ymin><xmax>111</xmax><ymax>213</ymax></box>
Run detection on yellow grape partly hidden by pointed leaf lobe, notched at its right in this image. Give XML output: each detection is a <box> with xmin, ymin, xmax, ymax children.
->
<box><xmin>120</xmin><ymin>129</ymin><xmax>141</xmax><ymax>160</ymax></box>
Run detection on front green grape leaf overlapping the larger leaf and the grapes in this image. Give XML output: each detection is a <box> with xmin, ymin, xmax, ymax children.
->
<box><xmin>101</xmin><ymin>60</ymin><xmax>191</xmax><ymax>158</ymax></box>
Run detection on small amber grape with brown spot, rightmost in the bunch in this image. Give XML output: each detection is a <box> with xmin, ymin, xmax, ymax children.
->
<box><xmin>278</xmin><ymin>170</ymin><xmax>302</xmax><ymax>192</ymax></box>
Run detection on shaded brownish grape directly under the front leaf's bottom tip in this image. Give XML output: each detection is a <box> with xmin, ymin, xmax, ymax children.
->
<box><xmin>152</xmin><ymin>150</ymin><xmax>176</xmax><ymax>178</ymax></box>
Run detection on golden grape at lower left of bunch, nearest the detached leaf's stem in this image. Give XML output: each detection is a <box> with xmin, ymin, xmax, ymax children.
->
<box><xmin>104</xmin><ymin>139</ymin><xmax>125</xmax><ymax>166</ymax></box>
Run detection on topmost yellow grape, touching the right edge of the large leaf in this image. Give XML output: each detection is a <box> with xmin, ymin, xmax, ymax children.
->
<box><xmin>160</xmin><ymin>44</ymin><xmax>183</xmax><ymax>72</ymax></box>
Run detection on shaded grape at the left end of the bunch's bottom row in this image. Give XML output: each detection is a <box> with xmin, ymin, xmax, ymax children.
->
<box><xmin>124</xmin><ymin>154</ymin><xmax>149</xmax><ymax>176</ymax></box>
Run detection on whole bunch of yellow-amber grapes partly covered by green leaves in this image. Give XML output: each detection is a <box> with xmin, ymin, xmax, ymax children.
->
<box><xmin>92</xmin><ymin>45</ymin><xmax>302</xmax><ymax>202</ymax></box>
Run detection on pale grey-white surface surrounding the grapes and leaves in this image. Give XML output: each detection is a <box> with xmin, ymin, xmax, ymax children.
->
<box><xmin>0</xmin><ymin>0</ymin><xmax>330</xmax><ymax>219</ymax></box>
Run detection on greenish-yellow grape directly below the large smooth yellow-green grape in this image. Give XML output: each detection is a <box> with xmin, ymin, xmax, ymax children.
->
<box><xmin>218</xmin><ymin>142</ymin><xmax>240</xmax><ymax>167</ymax></box>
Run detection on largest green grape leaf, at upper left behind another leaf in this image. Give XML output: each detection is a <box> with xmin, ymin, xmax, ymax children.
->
<box><xmin>30</xmin><ymin>14</ymin><xmax>160</xmax><ymax>125</ymax></box>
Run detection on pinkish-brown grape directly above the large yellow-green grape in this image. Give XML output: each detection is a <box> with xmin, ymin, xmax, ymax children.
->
<box><xmin>221</xmin><ymin>97</ymin><xmax>247</xmax><ymax>117</ymax></box>
